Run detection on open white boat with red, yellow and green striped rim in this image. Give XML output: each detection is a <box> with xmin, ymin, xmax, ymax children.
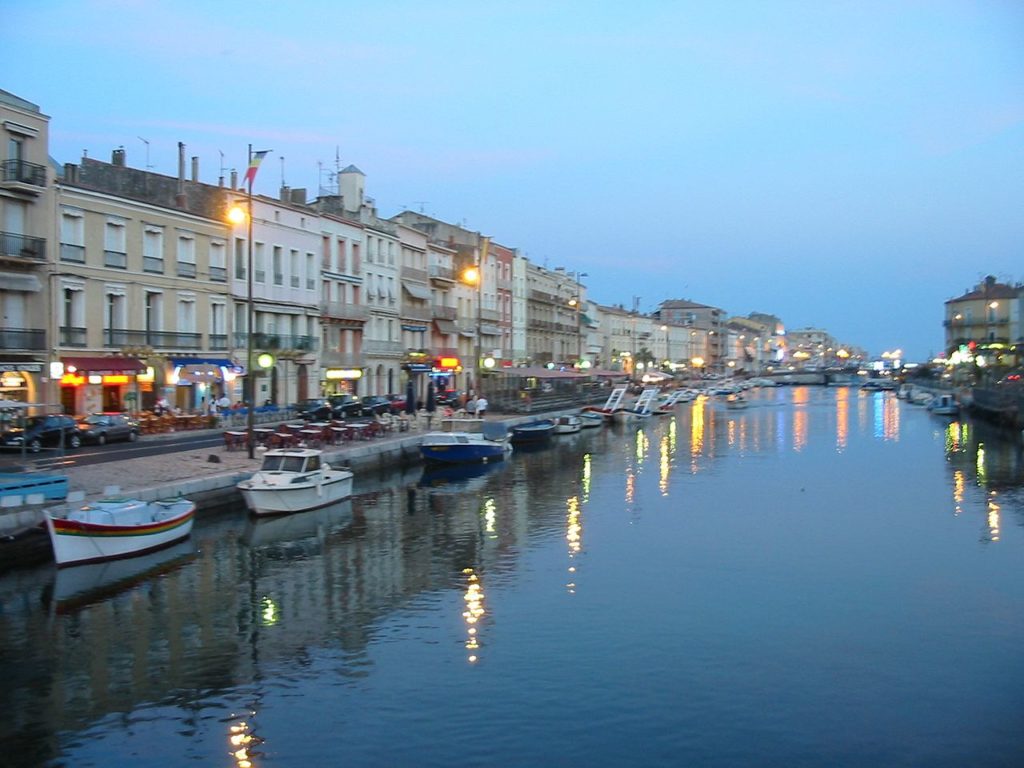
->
<box><xmin>46</xmin><ymin>498</ymin><xmax>196</xmax><ymax>565</ymax></box>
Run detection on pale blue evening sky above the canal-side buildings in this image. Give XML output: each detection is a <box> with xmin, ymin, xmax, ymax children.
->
<box><xmin>8</xmin><ymin>0</ymin><xmax>1024</xmax><ymax>360</ymax></box>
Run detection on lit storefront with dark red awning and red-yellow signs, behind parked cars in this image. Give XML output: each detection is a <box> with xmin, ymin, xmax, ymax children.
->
<box><xmin>54</xmin><ymin>356</ymin><xmax>146</xmax><ymax>414</ymax></box>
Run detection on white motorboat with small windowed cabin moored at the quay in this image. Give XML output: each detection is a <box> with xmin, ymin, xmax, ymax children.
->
<box><xmin>238</xmin><ymin>449</ymin><xmax>352</xmax><ymax>515</ymax></box>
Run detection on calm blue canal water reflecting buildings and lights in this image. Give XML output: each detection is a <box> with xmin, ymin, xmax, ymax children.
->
<box><xmin>0</xmin><ymin>387</ymin><xmax>1024</xmax><ymax>768</ymax></box>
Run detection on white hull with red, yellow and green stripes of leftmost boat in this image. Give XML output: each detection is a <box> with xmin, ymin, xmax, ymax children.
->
<box><xmin>46</xmin><ymin>501</ymin><xmax>196</xmax><ymax>565</ymax></box>
